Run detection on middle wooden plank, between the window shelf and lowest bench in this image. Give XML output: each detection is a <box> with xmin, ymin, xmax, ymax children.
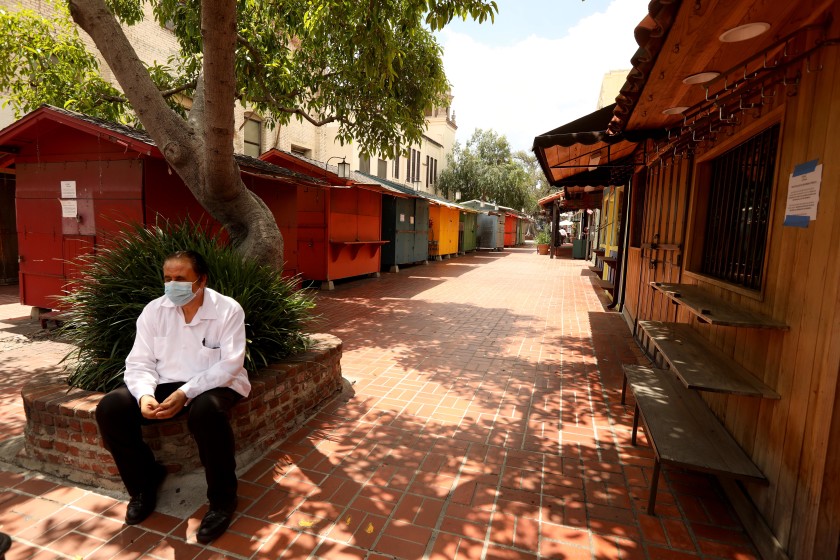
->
<box><xmin>639</xmin><ymin>321</ymin><xmax>781</xmax><ymax>399</ymax></box>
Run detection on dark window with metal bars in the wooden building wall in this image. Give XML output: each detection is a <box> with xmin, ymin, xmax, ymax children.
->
<box><xmin>701</xmin><ymin>125</ymin><xmax>779</xmax><ymax>290</ymax></box>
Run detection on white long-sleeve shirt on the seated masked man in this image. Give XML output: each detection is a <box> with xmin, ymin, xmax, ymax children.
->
<box><xmin>125</xmin><ymin>288</ymin><xmax>251</xmax><ymax>402</ymax></box>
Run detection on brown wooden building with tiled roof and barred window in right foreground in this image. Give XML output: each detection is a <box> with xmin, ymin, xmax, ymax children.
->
<box><xmin>534</xmin><ymin>0</ymin><xmax>840</xmax><ymax>560</ymax></box>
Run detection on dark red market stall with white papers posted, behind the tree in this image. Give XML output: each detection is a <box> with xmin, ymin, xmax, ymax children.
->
<box><xmin>0</xmin><ymin>106</ymin><xmax>315</xmax><ymax>308</ymax></box>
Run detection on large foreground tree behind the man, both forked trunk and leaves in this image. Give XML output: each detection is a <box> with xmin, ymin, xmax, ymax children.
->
<box><xmin>0</xmin><ymin>0</ymin><xmax>498</xmax><ymax>268</ymax></box>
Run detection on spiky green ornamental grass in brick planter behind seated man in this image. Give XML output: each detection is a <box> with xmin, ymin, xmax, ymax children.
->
<box><xmin>61</xmin><ymin>222</ymin><xmax>315</xmax><ymax>391</ymax></box>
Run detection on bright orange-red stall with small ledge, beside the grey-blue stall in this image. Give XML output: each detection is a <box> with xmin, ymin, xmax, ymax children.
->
<box><xmin>260</xmin><ymin>149</ymin><xmax>405</xmax><ymax>290</ymax></box>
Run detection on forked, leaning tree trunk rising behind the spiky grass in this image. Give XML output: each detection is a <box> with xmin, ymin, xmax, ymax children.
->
<box><xmin>69</xmin><ymin>0</ymin><xmax>283</xmax><ymax>268</ymax></box>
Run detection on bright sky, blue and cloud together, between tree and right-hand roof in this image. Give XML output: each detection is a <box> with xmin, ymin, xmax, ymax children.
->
<box><xmin>438</xmin><ymin>0</ymin><xmax>649</xmax><ymax>150</ymax></box>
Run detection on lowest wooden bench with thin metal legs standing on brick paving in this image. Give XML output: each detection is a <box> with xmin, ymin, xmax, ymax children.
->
<box><xmin>623</xmin><ymin>364</ymin><xmax>767</xmax><ymax>515</ymax></box>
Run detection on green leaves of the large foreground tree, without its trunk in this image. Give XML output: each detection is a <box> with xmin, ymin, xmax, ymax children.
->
<box><xmin>0</xmin><ymin>0</ymin><xmax>498</xmax><ymax>161</ymax></box>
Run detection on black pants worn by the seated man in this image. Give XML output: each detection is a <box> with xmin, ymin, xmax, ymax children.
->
<box><xmin>96</xmin><ymin>383</ymin><xmax>242</xmax><ymax>509</ymax></box>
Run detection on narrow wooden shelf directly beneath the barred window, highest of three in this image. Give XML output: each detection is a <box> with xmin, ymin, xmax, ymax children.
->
<box><xmin>650</xmin><ymin>282</ymin><xmax>789</xmax><ymax>329</ymax></box>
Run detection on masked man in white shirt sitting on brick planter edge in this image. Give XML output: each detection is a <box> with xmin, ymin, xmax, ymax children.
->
<box><xmin>96</xmin><ymin>251</ymin><xmax>251</xmax><ymax>544</ymax></box>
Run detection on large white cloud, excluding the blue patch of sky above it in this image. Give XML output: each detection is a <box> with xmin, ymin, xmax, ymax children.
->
<box><xmin>440</xmin><ymin>0</ymin><xmax>648</xmax><ymax>150</ymax></box>
